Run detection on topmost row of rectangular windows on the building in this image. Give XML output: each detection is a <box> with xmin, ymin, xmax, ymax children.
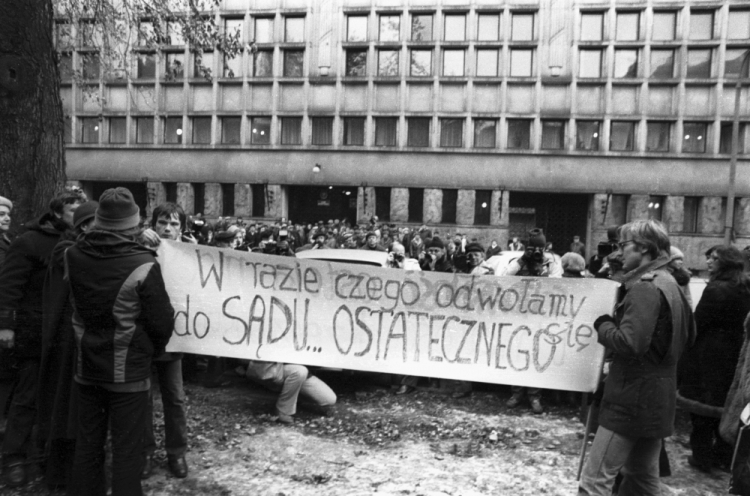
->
<box><xmin>56</xmin><ymin>7</ymin><xmax>750</xmax><ymax>48</ymax></box>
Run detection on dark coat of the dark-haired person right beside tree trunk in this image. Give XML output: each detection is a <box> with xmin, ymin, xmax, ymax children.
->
<box><xmin>0</xmin><ymin>214</ymin><xmax>66</xmax><ymax>360</ymax></box>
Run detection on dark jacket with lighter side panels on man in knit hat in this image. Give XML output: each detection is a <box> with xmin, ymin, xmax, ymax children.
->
<box><xmin>66</xmin><ymin>230</ymin><xmax>174</xmax><ymax>384</ymax></box>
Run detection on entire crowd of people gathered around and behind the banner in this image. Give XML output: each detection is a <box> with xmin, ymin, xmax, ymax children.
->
<box><xmin>0</xmin><ymin>188</ymin><xmax>750</xmax><ymax>496</ymax></box>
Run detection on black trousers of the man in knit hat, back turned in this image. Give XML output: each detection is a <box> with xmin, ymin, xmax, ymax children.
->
<box><xmin>68</xmin><ymin>384</ymin><xmax>148</xmax><ymax>496</ymax></box>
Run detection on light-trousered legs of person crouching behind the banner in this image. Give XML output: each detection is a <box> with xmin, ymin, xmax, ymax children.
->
<box><xmin>245</xmin><ymin>360</ymin><xmax>336</xmax><ymax>424</ymax></box>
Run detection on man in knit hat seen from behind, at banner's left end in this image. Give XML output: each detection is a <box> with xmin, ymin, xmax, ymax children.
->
<box><xmin>65</xmin><ymin>188</ymin><xmax>174</xmax><ymax>496</ymax></box>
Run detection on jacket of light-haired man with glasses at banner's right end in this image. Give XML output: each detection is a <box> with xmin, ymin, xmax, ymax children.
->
<box><xmin>597</xmin><ymin>257</ymin><xmax>695</xmax><ymax>438</ymax></box>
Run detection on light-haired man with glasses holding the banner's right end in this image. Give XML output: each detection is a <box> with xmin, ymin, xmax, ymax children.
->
<box><xmin>578</xmin><ymin>220</ymin><xmax>695</xmax><ymax>496</ymax></box>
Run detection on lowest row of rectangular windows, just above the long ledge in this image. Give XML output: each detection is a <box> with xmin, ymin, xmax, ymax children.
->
<box><xmin>66</xmin><ymin>116</ymin><xmax>745</xmax><ymax>153</ymax></box>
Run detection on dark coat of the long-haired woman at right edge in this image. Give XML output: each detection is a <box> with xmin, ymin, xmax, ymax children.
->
<box><xmin>680</xmin><ymin>280</ymin><xmax>750</xmax><ymax>413</ymax></box>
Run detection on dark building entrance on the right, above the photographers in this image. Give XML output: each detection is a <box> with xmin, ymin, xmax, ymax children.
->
<box><xmin>508</xmin><ymin>192</ymin><xmax>589</xmax><ymax>255</ymax></box>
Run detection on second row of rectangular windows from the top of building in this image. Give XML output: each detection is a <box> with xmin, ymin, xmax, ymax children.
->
<box><xmin>60</xmin><ymin>47</ymin><xmax>748</xmax><ymax>81</ymax></box>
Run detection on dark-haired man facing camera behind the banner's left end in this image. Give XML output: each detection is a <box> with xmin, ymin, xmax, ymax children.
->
<box><xmin>141</xmin><ymin>202</ymin><xmax>198</xmax><ymax>479</ymax></box>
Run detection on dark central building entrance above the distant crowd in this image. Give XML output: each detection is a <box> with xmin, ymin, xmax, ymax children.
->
<box><xmin>288</xmin><ymin>186</ymin><xmax>357</xmax><ymax>224</ymax></box>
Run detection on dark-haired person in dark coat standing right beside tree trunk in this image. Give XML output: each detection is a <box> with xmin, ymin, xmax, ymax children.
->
<box><xmin>0</xmin><ymin>189</ymin><xmax>86</xmax><ymax>486</ymax></box>
